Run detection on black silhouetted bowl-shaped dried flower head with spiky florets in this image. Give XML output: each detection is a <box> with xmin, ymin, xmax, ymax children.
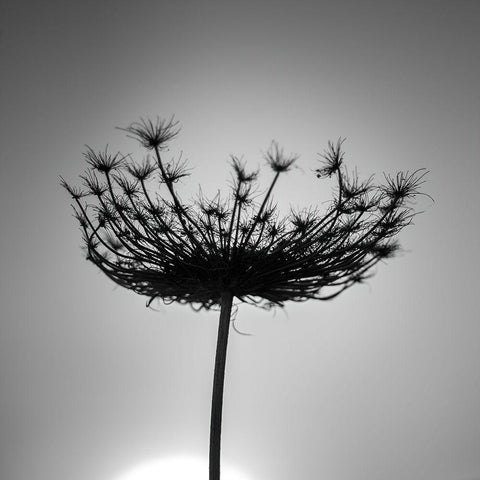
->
<box><xmin>62</xmin><ymin>119</ymin><xmax>427</xmax><ymax>309</ymax></box>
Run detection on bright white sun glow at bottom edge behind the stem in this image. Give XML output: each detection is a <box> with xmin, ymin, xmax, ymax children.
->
<box><xmin>115</xmin><ymin>457</ymin><xmax>250</xmax><ymax>480</ymax></box>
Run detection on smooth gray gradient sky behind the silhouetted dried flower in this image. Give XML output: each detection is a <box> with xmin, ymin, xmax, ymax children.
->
<box><xmin>0</xmin><ymin>0</ymin><xmax>480</xmax><ymax>480</ymax></box>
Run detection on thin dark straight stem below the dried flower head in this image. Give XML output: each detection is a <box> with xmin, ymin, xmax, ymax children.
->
<box><xmin>209</xmin><ymin>292</ymin><xmax>233</xmax><ymax>480</ymax></box>
